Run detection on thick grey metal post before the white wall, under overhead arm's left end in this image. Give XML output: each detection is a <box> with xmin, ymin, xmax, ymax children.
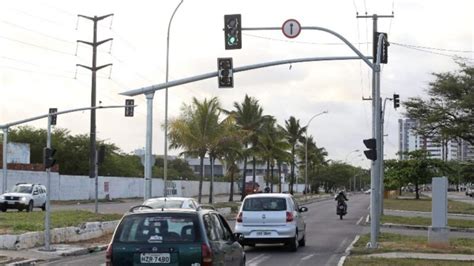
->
<box><xmin>143</xmin><ymin>92</ymin><xmax>155</xmax><ymax>200</ymax></box>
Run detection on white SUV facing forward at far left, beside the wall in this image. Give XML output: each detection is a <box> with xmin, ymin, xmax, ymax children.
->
<box><xmin>0</xmin><ymin>183</ymin><xmax>46</xmax><ymax>212</ymax></box>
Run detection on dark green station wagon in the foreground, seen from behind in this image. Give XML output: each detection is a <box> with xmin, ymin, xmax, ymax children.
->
<box><xmin>106</xmin><ymin>205</ymin><xmax>245</xmax><ymax>266</ymax></box>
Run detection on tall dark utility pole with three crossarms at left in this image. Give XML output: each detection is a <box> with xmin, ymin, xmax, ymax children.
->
<box><xmin>76</xmin><ymin>14</ymin><xmax>114</xmax><ymax>184</ymax></box>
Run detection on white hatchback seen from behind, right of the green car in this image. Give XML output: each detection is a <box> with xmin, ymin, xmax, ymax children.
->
<box><xmin>234</xmin><ymin>193</ymin><xmax>308</xmax><ymax>251</ymax></box>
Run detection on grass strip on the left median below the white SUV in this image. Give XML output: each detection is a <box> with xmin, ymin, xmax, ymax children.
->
<box><xmin>0</xmin><ymin>210</ymin><xmax>122</xmax><ymax>234</ymax></box>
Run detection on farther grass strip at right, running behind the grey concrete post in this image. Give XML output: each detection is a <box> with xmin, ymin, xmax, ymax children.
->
<box><xmin>384</xmin><ymin>198</ymin><xmax>474</xmax><ymax>215</ymax></box>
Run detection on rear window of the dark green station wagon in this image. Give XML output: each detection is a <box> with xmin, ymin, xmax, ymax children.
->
<box><xmin>115</xmin><ymin>213</ymin><xmax>200</xmax><ymax>243</ymax></box>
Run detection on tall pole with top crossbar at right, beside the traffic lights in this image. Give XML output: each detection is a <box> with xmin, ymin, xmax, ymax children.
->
<box><xmin>356</xmin><ymin>12</ymin><xmax>394</xmax><ymax>248</ymax></box>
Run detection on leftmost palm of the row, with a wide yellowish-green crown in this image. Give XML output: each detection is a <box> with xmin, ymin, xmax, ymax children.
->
<box><xmin>169</xmin><ymin>97</ymin><xmax>220</xmax><ymax>203</ymax></box>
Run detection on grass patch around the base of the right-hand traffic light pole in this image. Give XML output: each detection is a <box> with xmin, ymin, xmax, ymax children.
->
<box><xmin>351</xmin><ymin>233</ymin><xmax>474</xmax><ymax>256</ymax></box>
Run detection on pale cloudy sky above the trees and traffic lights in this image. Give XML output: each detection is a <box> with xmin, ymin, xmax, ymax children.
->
<box><xmin>0</xmin><ymin>0</ymin><xmax>474</xmax><ymax>167</ymax></box>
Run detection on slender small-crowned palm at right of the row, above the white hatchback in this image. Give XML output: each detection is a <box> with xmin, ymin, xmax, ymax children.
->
<box><xmin>285</xmin><ymin>116</ymin><xmax>306</xmax><ymax>194</ymax></box>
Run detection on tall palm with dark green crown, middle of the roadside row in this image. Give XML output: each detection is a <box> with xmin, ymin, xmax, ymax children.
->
<box><xmin>225</xmin><ymin>95</ymin><xmax>265</xmax><ymax>200</ymax></box>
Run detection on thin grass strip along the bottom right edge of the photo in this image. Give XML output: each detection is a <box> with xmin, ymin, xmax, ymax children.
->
<box><xmin>344</xmin><ymin>257</ymin><xmax>473</xmax><ymax>266</ymax></box>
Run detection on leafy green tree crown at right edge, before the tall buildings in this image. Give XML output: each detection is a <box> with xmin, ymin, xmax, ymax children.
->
<box><xmin>404</xmin><ymin>63</ymin><xmax>474</xmax><ymax>145</ymax></box>
